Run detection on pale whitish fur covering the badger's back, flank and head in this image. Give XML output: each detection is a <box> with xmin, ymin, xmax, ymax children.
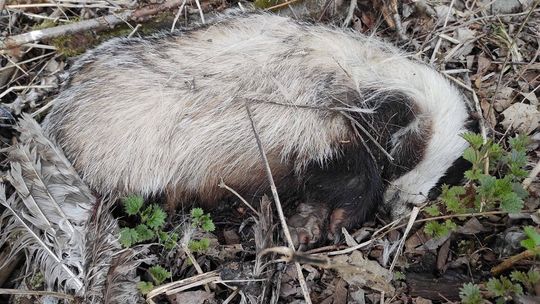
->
<box><xmin>44</xmin><ymin>14</ymin><xmax>467</xmax><ymax>210</ymax></box>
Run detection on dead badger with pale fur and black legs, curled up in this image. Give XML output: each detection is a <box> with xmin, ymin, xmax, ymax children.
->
<box><xmin>43</xmin><ymin>14</ymin><xmax>468</xmax><ymax>243</ymax></box>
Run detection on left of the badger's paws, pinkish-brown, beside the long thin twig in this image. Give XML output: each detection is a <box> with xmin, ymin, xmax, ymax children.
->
<box><xmin>287</xmin><ymin>203</ymin><xmax>330</xmax><ymax>250</ymax></box>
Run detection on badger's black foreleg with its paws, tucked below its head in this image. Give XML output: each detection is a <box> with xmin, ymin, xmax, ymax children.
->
<box><xmin>289</xmin><ymin>145</ymin><xmax>384</xmax><ymax>245</ymax></box>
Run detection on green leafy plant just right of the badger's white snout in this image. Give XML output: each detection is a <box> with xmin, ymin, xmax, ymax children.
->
<box><xmin>424</xmin><ymin>133</ymin><xmax>528</xmax><ymax>237</ymax></box>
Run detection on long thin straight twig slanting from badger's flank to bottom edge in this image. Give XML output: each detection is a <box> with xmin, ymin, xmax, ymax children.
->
<box><xmin>244</xmin><ymin>102</ymin><xmax>312</xmax><ymax>304</ymax></box>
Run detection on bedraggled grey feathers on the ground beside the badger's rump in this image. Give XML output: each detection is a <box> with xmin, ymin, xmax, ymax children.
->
<box><xmin>0</xmin><ymin>115</ymin><xmax>148</xmax><ymax>303</ymax></box>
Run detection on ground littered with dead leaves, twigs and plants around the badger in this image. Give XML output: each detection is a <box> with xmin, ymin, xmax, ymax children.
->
<box><xmin>0</xmin><ymin>0</ymin><xmax>540</xmax><ymax>304</ymax></box>
